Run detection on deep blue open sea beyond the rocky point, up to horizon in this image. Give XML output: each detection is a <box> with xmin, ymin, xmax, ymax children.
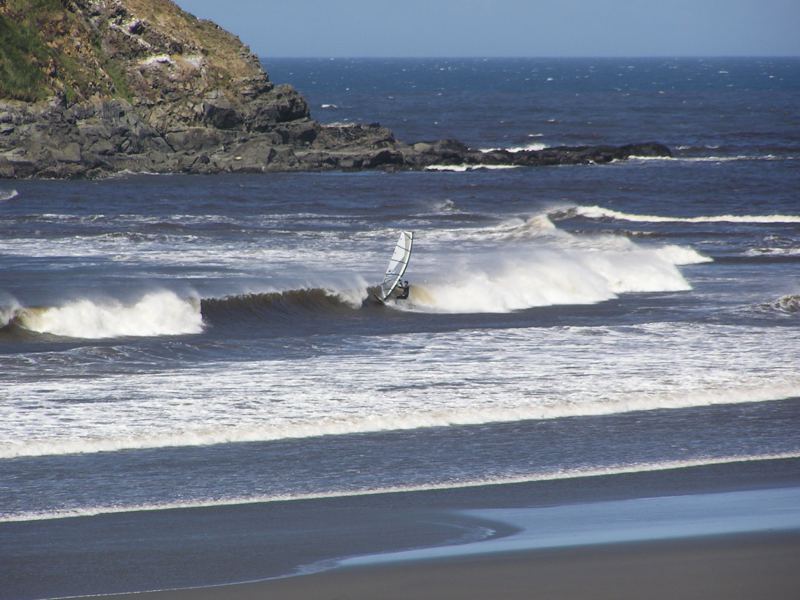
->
<box><xmin>265</xmin><ymin>58</ymin><xmax>800</xmax><ymax>151</ymax></box>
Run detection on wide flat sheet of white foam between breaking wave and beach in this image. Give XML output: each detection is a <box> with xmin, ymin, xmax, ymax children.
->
<box><xmin>0</xmin><ymin>323</ymin><xmax>800</xmax><ymax>458</ymax></box>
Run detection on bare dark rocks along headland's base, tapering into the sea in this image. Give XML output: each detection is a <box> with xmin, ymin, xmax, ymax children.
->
<box><xmin>0</xmin><ymin>92</ymin><xmax>670</xmax><ymax>178</ymax></box>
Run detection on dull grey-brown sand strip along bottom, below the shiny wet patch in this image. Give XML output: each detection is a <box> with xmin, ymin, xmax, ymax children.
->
<box><xmin>106</xmin><ymin>533</ymin><xmax>800</xmax><ymax>600</ymax></box>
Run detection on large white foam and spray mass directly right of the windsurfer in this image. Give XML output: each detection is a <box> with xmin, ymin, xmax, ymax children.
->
<box><xmin>372</xmin><ymin>206</ymin><xmax>711</xmax><ymax>313</ymax></box>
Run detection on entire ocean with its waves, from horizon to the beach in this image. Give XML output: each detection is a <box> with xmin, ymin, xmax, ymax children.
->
<box><xmin>0</xmin><ymin>58</ymin><xmax>800</xmax><ymax>597</ymax></box>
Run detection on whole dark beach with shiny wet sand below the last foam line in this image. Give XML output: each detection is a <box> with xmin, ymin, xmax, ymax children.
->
<box><xmin>0</xmin><ymin>459</ymin><xmax>800</xmax><ymax>600</ymax></box>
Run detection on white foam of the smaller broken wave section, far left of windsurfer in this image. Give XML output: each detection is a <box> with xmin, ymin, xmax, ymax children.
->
<box><xmin>18</xmin><ymin>290</ymin><xmax>203</xmax><ymax>339</ymax></box>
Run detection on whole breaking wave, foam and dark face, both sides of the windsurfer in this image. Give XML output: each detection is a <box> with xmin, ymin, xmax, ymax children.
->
<box><xmin>0</xmin><ymin>213</ymin><xmax>711</xmax><ymax>330</ymax></box>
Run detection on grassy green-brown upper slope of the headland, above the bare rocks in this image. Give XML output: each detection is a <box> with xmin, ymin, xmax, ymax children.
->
<box><xmin>0</xmin><ymin>0</ymin><xmax>269</xmax><ymax>106</ymax></box>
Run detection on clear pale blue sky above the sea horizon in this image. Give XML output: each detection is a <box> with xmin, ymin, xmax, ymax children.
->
<box><xmin>177</xmin><ymin>0</ymin><xmax>800</xmax><ymax>57</ymax></box>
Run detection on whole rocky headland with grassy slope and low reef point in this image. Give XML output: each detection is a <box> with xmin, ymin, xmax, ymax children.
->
<box><xmin>0</xmin><ymin>0</ymin><xmax>670</xmax><ymax>178</ymax></box>
